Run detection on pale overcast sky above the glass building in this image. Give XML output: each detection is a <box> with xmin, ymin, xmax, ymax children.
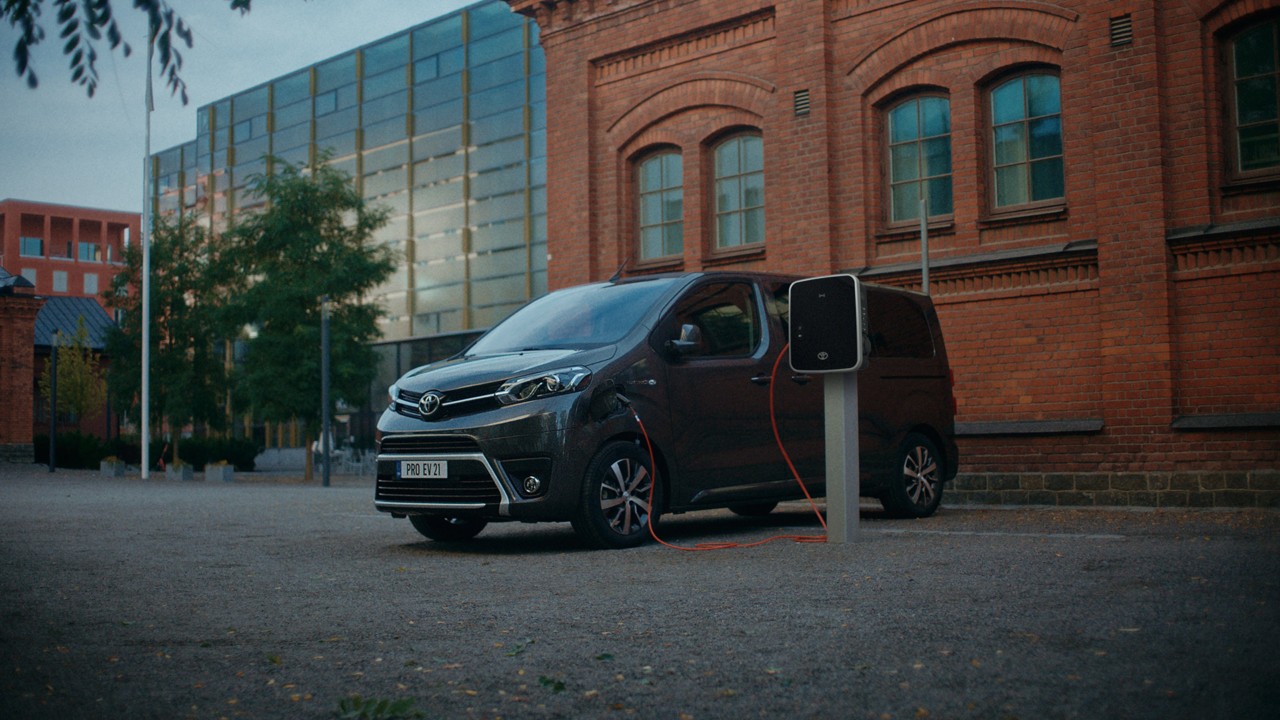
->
<box><xmin>0</xmin><ymin>0</ymin><xmax>475</xmax><ymax>213</ymax></box>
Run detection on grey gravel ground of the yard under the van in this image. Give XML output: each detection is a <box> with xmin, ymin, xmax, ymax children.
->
<box><xmin>0</xmin><ymin>465</ymin><xmax>1280</xmax><ymax>720</ymax></box>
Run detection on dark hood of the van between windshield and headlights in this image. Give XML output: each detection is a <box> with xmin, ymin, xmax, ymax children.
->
<box><xmin>396</xmin><ymin>345</ymin><xmax>617</xmax><ymax>392</ymax></box>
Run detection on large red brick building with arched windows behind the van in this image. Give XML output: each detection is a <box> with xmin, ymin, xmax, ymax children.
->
<box><xmin>508</xmin><ymin>0</ymin><xmax>1280</xmax><ymax>505</ymax></box>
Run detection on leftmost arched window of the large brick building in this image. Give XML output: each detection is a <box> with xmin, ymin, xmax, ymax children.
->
<box><xmin>635</xmin><ymin>149</ymin><xmax>685</xmax><ymax>260</ymax></box>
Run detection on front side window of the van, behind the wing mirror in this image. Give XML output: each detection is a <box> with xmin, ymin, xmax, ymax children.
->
<box><xmin>676</xmin><ymin>283</ymin><xmax>760</xmax><ymax>357</ymax></box>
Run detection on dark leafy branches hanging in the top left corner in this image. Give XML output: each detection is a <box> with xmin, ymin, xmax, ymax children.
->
<box><xmin>0</xmin><ymin>0</ymin><xmax>252</xmax><ymax>105</ymax></box>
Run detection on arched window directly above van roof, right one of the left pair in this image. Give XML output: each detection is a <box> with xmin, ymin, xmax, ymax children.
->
<box><xmin>712</xmin><ymin>132</ymin><xmax>764</xmax><ymax>250</ymax></box>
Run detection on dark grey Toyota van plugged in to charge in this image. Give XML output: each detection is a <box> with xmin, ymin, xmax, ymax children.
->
<box><xmin>375</xmin><ymin>273</ymin><xmax>957</xmax><ymax>547</ymax></box>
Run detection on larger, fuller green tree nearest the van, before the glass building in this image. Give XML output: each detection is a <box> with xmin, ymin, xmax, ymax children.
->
<box><xmin>220</xmin><ymin>159</ymin><xmax>394</xmax><ymax>475</ymax></box>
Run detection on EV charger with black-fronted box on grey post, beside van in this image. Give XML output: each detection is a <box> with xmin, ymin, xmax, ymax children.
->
<box><xmin>788</xmin><ymin>275</ymin><xmax>865</xmax><ymax>543</ymax></box>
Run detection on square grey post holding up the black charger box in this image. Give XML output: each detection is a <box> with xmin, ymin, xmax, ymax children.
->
<box><xmin>823</xmin><ymin>373</ymin><xmax>861</xmax><ymax>543</ymax></box>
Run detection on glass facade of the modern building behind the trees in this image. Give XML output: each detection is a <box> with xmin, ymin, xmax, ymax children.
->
<box><xmin>152</xmin><ymin>0</ymin><xmax>547</xmax><ymax>341</ymax></box>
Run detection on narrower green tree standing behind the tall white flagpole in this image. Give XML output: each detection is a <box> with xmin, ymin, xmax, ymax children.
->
<box><xmin>104</xmin><ymin>210</ymin><xmax>228</xmax><ymax>461</ymax></box>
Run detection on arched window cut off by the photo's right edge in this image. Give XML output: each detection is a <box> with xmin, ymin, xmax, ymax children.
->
<box><xmin>1228</xmin><ymin>17</ymin><xmax>1280</xmax><ymax>176</ymax></box>
